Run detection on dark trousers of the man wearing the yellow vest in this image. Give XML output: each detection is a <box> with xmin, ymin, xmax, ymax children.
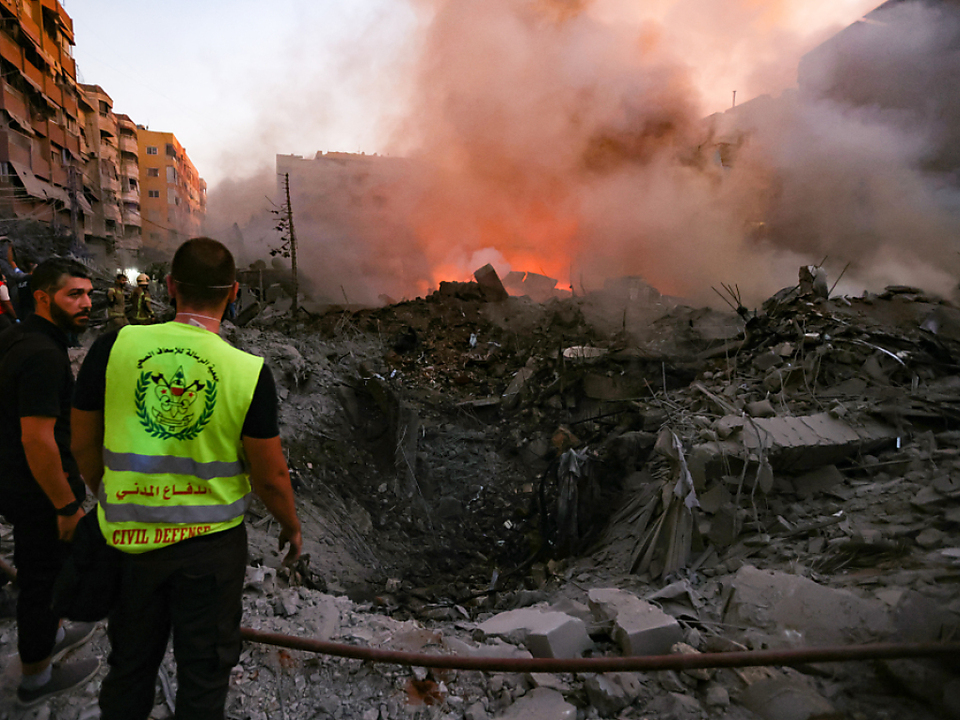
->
<box><xmin>100</xmin><ymin>524</ymin><xmax>247</xmax><ymax>720</ymax></box>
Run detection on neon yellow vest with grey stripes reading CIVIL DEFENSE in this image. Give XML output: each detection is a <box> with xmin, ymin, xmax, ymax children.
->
<box><xmin>98</xmin><ymin>322</ymin><xmax>263</xmax><ymax>553</ymax></box>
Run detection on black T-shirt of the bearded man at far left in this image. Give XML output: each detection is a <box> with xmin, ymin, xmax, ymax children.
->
<box><xmin>0</xmin><ymin>315</ymin><xmax>83</xmax><ymax>498</ymax></box>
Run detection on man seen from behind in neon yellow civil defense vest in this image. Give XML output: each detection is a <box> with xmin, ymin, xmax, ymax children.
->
<box><xmin>72</xmin><ymin>238</ymin><xmax>301</xmax><ymax>720</ymax></box>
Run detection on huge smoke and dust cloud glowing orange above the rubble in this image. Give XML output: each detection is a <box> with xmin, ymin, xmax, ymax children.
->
<box><xmin>209</xmin><ymin>0</ymin><xmax>960</xmax><ymax>303</ymax></box>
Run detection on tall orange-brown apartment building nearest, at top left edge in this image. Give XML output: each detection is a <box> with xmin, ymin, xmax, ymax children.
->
<box><xmin>0</xmin><ymin>0</ymin><xmax>91</xmax><ymax>237</ymax></box>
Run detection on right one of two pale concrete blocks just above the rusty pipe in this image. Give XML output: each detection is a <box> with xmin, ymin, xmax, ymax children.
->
<box><xmin>587</xmin><ymin>588</ymin><xmax>683</xmax><ymax>655</ymax></box>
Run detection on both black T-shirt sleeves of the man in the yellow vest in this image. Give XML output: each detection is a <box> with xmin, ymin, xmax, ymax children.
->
<box><xmin>73</xmin><ymin>330</ymin><xmax>280</xmax><ymax>440</ymax></box>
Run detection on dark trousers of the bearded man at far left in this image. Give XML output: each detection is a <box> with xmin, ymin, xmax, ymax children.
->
<box><xmin>0</xmin><ymin>498</ymin><xmax>70</xmax><ymax>663</ymax></box>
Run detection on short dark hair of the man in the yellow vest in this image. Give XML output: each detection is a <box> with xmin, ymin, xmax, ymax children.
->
<box><xmin>170</xmin><ymin>237</ymin><xmax>237</xmax><ymax>307</ymax></box>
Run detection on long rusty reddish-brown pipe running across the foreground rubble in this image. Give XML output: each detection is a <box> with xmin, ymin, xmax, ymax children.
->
<box><xmin>240</xmin><ymin>628</ymin><xmax>960</xmax><ymax>673</ymax></box>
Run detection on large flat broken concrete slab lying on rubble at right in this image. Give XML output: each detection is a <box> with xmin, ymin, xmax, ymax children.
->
<box><xmin>741</xmin><ymin>412</ymin><xmax>897</xmax><ymax>472</ymax></box>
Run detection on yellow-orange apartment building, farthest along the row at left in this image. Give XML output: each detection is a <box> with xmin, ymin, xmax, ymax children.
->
<box><xmin>137</xmin><ymin>126</ymin><xmax>207</xmax><ymax>259</ymax></box>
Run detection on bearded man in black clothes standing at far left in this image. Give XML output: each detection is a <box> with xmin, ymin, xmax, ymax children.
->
<box><xmin>0</xmin><ymin>258</ymin><xmax>100</xmax><ymax>707</ymax></box>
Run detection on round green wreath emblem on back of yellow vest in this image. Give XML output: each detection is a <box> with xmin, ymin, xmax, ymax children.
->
<box><xmin>134</xmin><ymin>348</ymin><xmax>217</xmax><ymax>440</ymax></box>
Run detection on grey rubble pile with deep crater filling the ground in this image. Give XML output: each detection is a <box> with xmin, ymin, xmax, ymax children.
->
<box><xmin>0</xmin><ymin>268</ymin><xmax>960</xmax><ymax>720</ymax></box>
